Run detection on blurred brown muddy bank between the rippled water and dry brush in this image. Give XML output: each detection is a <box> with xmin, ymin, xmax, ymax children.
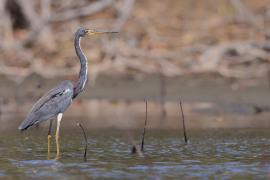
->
<box><xmin>0</xmin><ymin>74</ymin><xmax>270</xmax><ymax>130</ymax></box>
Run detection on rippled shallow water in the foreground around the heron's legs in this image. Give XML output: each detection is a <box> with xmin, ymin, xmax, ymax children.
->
<box><xmin>0</xmin><ymin>128</ymin><xmax>270</xmax><ymax>179</ymax></box>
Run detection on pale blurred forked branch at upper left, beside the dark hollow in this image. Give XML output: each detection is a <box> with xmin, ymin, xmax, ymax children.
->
<box><xmin>3</xmin><ymin>0</ymin><xmax>114</xmax><ymax>48</ymax></box>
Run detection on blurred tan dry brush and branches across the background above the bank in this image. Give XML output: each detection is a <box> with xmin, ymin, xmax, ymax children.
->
<box><xmin>0</xmin><ymin>0</ymin><xmax>270</xmax><ymax>83</ymax></box>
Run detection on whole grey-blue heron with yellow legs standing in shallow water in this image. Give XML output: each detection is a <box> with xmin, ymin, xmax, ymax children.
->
<box><xmin>18</xmin><ymin>27</ymin><xmax>115</xmax><ymax>159</ymax></box>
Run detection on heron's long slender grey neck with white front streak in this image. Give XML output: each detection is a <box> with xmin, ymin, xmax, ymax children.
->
<box><xmin>73</xmin><ymin>33</ymin><xmax>87</xmax><ymax>98</ymax></box>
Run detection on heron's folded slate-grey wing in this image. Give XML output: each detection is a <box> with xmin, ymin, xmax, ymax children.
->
<box><xmin>19</xmin><ymin>81</ymin><xmax>73</xmax><ymax>130</ymax></box>
